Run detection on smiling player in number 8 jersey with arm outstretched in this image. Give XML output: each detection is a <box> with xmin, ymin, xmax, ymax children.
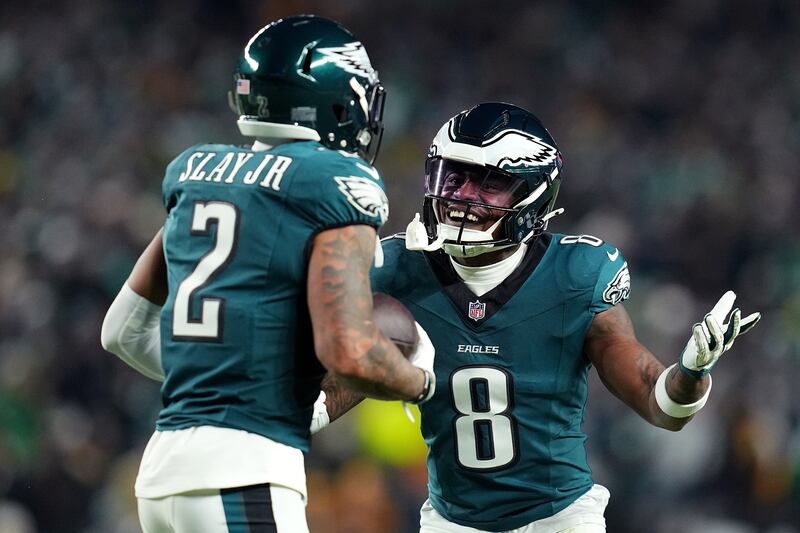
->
<box><xmin>314</xmin><ymin>103</ymin><xmax>760</xmax><ymax>533</ymax></box>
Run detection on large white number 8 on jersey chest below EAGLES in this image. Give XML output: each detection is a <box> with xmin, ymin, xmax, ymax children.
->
<box><xmin>450</xmin><ymin>366</ymin><xmax>519</xmax><ymax>471</ymax></box>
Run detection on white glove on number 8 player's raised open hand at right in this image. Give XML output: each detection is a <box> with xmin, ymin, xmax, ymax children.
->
<box><xmin>679</xmin><ymin>291</ymin><xmax>761</xmax><ymax>379</ymax></box>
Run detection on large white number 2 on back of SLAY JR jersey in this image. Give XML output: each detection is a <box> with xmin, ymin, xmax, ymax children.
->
<box><xmin>172</xmin><ymin>202</ymin><xmax>239</xmax><ymax>341</ymax></box>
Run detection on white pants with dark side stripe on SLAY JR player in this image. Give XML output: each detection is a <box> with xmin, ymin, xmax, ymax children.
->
<box><xmin>139</xmin><ymin>484</ymin><xmax>308</xmax><ymax>533</ymax></box>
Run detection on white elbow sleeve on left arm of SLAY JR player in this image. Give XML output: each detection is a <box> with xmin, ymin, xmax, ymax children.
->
<box><xmin>100</xmin><ymin>282</ymin><xmax>164</xmax><ymax>381</ymax></box>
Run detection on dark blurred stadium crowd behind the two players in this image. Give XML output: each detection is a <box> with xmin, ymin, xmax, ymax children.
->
<box><xmin>0</xmin><ymin>0</ymin><xmax>800</xmax><ymax>533</ymax></box>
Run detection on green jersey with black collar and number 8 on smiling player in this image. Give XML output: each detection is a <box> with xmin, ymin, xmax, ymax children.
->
<box><xmin>372</xmin><ymin>233</ymin><xmax>630</xmax><ymax>531</ymax></box>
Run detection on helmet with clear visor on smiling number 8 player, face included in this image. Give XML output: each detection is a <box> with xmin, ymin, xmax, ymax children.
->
<box><xmin>416</xmin><ymin>102</ymin><xmax>563</xmax><ymax>257</ymax></box>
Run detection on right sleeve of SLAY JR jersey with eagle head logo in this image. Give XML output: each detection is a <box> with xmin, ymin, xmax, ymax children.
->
<box><xmin>292</xmin><ymin>151</ymin><xmax>389</xmax><ymax>231</ymax></box>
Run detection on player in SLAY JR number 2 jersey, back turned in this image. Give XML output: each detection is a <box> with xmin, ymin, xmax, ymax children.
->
<box><xmin>101</xmin><ymin>16</ymin><xmax>435</xmax><ymax>533</ymax></box>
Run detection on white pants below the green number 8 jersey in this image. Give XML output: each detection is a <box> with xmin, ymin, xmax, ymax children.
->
<box><xmin>419</xmin><ymin>485</ymin><xmax>610</xmax><ymax>533</ymax></box>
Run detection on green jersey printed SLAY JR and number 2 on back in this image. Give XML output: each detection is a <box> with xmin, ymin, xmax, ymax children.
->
<box><xmin>157</xmin><ymin>142</ymin><xmax>388</xmax><ymax>452</ymax></box>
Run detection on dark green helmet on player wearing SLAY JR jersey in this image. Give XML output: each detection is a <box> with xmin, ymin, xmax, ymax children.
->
<box><xmin>229</xmin><ymin>15</ymin><xmax>386</xmax><ymax>163</ymax></box>
